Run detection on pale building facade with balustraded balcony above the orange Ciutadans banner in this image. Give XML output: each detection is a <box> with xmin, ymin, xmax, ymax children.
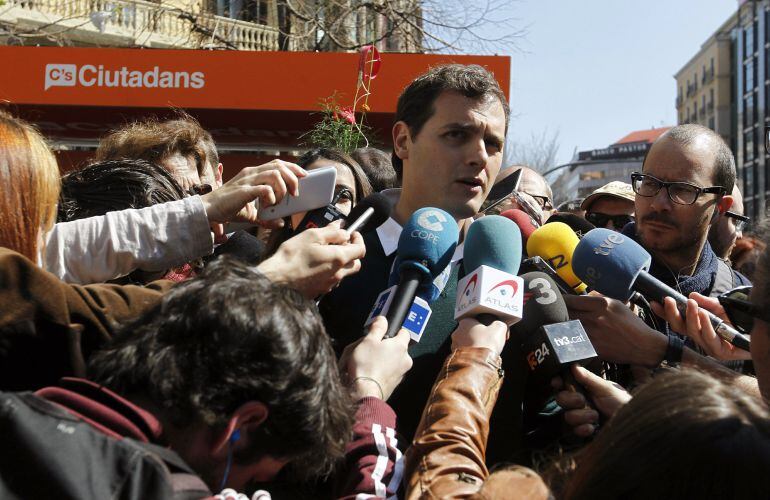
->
<box><xmin>0</xmin><ymin>0</ymin><xmax>422</xmax><ymax>52</ymax></box>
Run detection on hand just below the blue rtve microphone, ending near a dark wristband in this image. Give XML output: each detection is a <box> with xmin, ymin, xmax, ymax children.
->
<box><xmin>564</xmin><ymin>292</ymin><xmax>668</xmax><ymax>368</ymax></box>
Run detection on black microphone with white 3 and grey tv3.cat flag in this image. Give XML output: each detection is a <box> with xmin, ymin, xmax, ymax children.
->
<box><xmin>511</xmin><ymin>271</ymin><xmax>596</xmax><ymax>386</ymax></box>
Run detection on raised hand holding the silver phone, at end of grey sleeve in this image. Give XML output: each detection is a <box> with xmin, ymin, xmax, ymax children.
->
<box><xmin>201</xmin><ymin>160</ymin><xmax>307</xmax><ymax>224</ymax></box>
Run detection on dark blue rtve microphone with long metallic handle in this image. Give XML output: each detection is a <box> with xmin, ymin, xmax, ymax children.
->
<box><xmin>573</xmin><ymin>228</ymin><xmax>750</xmax><ymax>351</ymax></box>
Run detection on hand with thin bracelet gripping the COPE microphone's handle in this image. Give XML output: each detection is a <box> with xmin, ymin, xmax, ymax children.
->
<box><xmin>339</xmin><ymin>316</ymin><xmax>412</xmax><ymax>401</ymax></box>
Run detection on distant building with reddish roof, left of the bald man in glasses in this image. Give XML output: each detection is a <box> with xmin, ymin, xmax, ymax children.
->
<box><xmin>551</xmin><ymin>127</ymin><xmax>668</xmax><ymax>205</ymax></box>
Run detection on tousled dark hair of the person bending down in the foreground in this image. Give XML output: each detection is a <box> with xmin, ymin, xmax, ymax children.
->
<box><xmin>89</xmin><ymin>258</ymin><xmax>353</xmax><ymax>476</ymax></box>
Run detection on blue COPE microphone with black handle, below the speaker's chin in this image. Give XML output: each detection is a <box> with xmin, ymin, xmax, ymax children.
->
<box><xmin>370</xmin><ymin>207</ymin><xmax>460</xmax><ymax>338</ymax></box>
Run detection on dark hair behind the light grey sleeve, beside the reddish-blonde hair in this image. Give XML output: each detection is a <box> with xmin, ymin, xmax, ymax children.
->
<box><xmin>58</xmin><ymin>159</ymin><xmax>185</xmax><ymax>222</ymax></box>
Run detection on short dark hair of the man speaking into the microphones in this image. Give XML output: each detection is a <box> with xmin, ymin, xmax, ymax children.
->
<box><xmin>393</xmin><ymin>64</ymin><xmax>510</xmax><ymax>179</ymax></box>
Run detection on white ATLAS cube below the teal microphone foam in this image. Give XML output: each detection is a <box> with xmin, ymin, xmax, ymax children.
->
<box><xmin>455</xmin><ymin>265</ymin><xmax>524</xmax><ymax>325</ymax></box>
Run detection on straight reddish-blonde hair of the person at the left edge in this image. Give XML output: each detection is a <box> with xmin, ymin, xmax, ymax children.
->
<box><xmin>0</xmin><ymin>110</ymin><xmax>60</xmax><ymax>261</ymax></box>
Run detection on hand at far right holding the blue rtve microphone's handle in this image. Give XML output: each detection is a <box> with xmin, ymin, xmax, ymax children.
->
<box><xmin>650</xmin><ymin>292</ymin><xmax>751</xmax><ymax>361</ymax></box>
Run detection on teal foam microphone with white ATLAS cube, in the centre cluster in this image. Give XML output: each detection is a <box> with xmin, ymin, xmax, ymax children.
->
<box><xmin>454</xmin><ymin>215</ymin><xmax>524</xmax><ymax>325</ymax></box>
